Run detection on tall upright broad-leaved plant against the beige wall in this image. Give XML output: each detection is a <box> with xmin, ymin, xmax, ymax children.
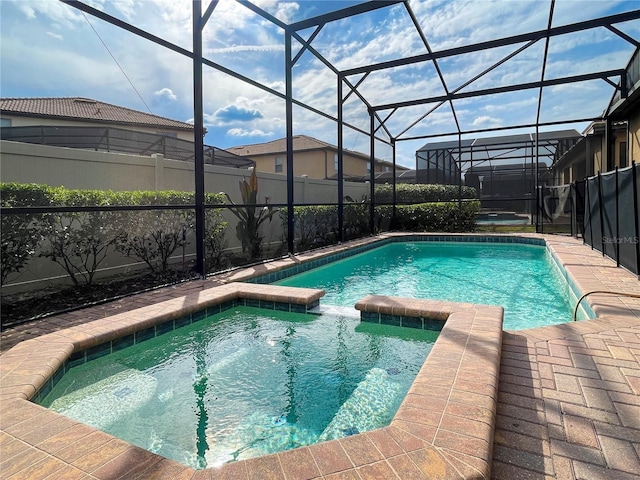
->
<box><xmin>223</xmin><ymin>169</ymin><xmax>276</xmax><ymax>259</ymax></box>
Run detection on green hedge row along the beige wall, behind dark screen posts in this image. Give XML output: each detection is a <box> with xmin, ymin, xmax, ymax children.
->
<box><xmin>0</xmin><ymin>183</ymin><xmax>480</xmax><ymax>285</ymax></box>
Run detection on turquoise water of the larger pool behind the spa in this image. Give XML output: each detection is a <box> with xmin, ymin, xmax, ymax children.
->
<box><xmin>277</xmin><ymin>242</ymin><xmax>574</xmax><ymax>330</ymax></box>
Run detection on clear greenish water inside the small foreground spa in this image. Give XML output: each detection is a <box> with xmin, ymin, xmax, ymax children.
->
<box><xmin>42</xmin><ymin>307</ymin><xmax>438</xmax><ymax>468</ymax></box>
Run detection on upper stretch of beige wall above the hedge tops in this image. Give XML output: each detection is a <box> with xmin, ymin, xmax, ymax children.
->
<box><xmin>0</xmin><ymin>141</ymin><xmax>368</xmax><ymax>203</ymax></box>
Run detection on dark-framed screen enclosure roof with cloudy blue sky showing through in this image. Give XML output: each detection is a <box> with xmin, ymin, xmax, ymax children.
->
<box><xmin>6</xmin><ymin>0</ymin><xmax>640</xmax><ymax>271</ymax></box>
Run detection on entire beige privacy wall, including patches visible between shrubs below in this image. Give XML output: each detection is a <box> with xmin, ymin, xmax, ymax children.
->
<box><xmin>0</xmin><ymin>141</ymin><xmax>369</xmax><ymax>291</ymax></box>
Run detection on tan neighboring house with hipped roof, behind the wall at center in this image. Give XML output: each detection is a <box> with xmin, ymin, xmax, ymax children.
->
<box><xmin>227</xmin><ymin>135</ymin><xmax>408</xmax><ymax>181</ymax></box>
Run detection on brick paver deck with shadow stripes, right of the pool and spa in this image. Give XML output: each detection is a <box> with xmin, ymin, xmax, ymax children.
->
<box><xmin>492</xmin><ymin>237</ymin><xmax>640</xmax><ymax>480</ymax></box>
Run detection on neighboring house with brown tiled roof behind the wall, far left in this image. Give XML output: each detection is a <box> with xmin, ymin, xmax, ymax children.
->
<box><xmin>0</xmin><ymin>97</ymin><xmax>253</xmax><ymax>168</ymax></box>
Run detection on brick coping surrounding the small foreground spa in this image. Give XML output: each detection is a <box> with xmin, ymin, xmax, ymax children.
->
<box><xmin>0</xmin><ymin>283</ymin><xmax>502</xmax><ymax>479</ymax></box>
